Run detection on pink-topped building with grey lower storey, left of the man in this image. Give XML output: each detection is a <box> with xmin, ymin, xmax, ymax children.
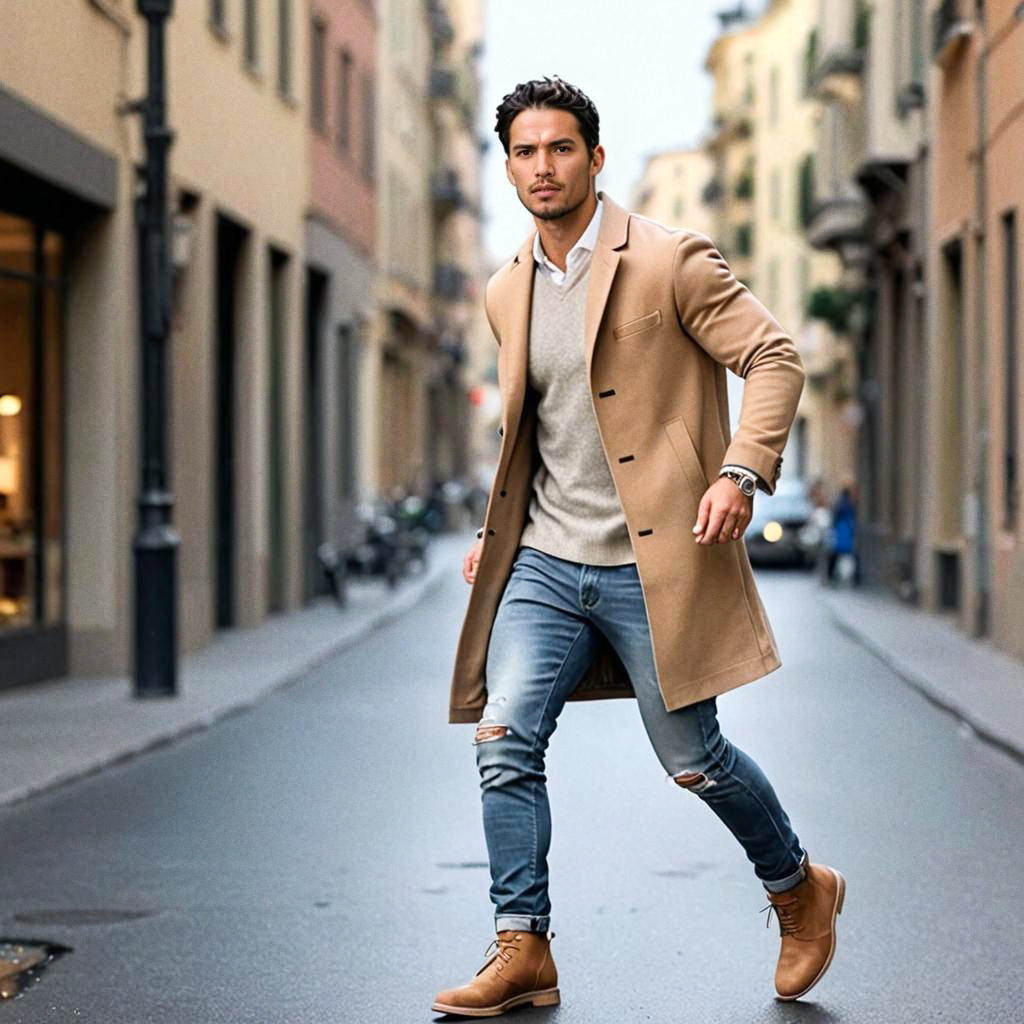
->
<box><xmin>303</xmin><ymin>0</ymin><xmax>378</xmax><ymax>596</ymax></box>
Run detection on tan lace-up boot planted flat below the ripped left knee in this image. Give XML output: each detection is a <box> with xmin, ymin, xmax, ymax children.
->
<box><xmin>431</xmin><ymin>932</ymin><xmax>559</xmax><ymax>1017</ymax></box>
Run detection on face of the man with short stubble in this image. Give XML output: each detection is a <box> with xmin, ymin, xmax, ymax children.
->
<box><xmin>505</xmin><ymin>109</ymin><xmax>604</xmax><ymax>220</ymax></box>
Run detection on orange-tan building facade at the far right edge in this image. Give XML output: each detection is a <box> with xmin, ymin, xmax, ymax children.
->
<box><xmin>929</xmin><ymin>0</ymin><xmax>1024</xmax><ymax>656</ymax></box>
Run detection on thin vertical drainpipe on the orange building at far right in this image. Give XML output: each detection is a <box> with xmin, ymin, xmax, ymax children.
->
<box><xmin>968</xmin><ymin>0</ymin><xmax>991</xmax><ymax>637</ymax></box>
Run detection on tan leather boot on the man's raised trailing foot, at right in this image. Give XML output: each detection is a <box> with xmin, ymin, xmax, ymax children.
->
<box><xmin>766</xmin><ymin>864</ymin><xmax>846</xmax><ymax>999</ymax></box>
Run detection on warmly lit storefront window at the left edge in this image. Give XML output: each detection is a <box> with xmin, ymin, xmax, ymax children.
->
<box><xmin>0</xmin><ymin>213</ymin><xmax>63</xmax><ymax>631</ymax></box>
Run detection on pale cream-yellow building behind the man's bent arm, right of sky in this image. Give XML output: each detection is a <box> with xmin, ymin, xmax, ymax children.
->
<box><xmin>707</xmin><ymin>0</ymin><xmax>858</xmax><ymax>496</ymax></box>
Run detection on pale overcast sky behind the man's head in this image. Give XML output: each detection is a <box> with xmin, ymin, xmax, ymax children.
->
<box><xmin>480</xmin><ymin>0</ymin><xmax>761</xmax><ymax>263</ymax></box>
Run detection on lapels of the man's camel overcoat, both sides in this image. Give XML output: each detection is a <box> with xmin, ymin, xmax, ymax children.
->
<box><xmin>499</xmin><ymin>191</ymin><xmax>630</xmax><ymax>441</ymax></box>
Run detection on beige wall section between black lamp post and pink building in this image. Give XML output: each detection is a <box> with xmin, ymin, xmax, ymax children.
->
<box><xmin>163</xmin><ymin>0</ymin><xmax>309</xmax><ymax>649</ymax></box>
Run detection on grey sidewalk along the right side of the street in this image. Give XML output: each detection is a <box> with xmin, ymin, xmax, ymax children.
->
<box><xmin>825</xmin><ymin>590</ymin><xmax>1024</xmax><ymax>761</ymax></box>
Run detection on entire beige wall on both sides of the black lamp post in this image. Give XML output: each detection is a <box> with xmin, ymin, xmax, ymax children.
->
<box><xmin>0</xmin><ymin>0</ymin><xmax>308</xmax><ymax>673</ymax></box>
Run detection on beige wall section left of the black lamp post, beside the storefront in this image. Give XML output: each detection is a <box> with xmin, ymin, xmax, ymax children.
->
<box><xmin>0</xmin><ymin>0</ymin><xmax>138</xmax><ymax>673</ymax></box>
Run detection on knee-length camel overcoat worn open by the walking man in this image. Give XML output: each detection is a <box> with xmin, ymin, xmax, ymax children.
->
<box><xmin>450</xmin><ymin>194</ymin><xmax>804</xmax><ymax>722</ymax></box>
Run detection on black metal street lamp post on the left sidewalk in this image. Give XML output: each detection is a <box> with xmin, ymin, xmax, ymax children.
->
<box><xmin>135</xmin><ymin>0</ymin><xmax>179</xmax><ymax>697</ymax></box>
